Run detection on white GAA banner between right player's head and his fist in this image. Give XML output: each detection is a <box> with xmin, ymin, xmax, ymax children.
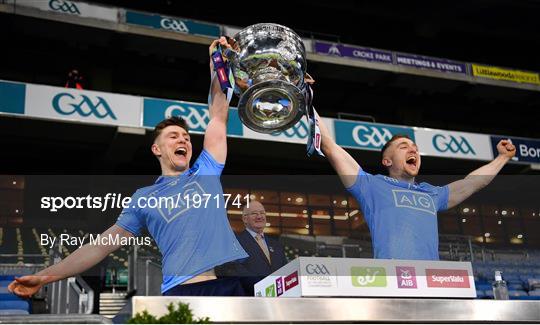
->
<box><xmin>415</xmin><ymin>128</ymin><xmax>493</xmax><ymax>160</ymax></box>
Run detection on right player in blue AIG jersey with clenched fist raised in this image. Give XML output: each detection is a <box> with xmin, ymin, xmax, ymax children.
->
<box><xmin>318</xmin><ymin>118</ymin><xmax>516</xmax><ymax>260</ymax></box>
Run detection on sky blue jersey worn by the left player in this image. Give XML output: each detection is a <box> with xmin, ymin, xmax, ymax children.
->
<box><xmin>116</xmin><ymin>150</ymin><xmax>248</xmax><ymax>292</ymax></box>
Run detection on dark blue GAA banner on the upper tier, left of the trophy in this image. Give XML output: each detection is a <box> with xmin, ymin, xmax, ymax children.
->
<box><xmin>126</xmin><ymin>11</ymin><xmax>221</xmax><ymax>37</ymax></box>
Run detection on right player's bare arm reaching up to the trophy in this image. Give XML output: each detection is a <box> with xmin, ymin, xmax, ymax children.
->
<box><xmin>317</xmin><ymin>115</ymin><xmax>360</xmax><ymax>187</ymax></box>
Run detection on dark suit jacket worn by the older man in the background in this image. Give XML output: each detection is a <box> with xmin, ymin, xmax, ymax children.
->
<box><xmin>218</xmin><ymin>230</ymin><xmax>288</xmax><ymax>296</ymax></box>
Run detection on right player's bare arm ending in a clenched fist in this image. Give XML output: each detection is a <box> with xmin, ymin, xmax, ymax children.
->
<box><xmin>448</xmin><ymin>140</ymin><xmax>516</xmax><ymax>209</ymax></box>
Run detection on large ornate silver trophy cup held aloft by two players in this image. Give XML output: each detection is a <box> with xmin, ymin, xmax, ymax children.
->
<box><xmin>226</xmin><ymin>24</ymin><xmax>306</xmax><ymax>133</ymax></box>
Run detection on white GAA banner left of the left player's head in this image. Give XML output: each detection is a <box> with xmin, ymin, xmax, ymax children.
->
<box><xmin>25</xmin><ymin>85</ymin><xmax>142</xmax><ymax>127</ymax></box>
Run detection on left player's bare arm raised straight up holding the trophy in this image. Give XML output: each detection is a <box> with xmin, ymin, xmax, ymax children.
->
<box><xmin>204</xmin><ymin>37</ymin><xmax>230</xmax><ymax>164</ymax></box>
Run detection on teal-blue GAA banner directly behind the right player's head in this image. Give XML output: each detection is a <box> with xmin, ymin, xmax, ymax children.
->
<box><xmin>334</xmin><ymin>120</ymin><xmax>414</xmax><ymax>150</ymax></box>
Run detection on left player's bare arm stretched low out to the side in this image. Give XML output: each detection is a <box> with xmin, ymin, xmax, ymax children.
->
<box><xmin>8</xmin><ymin>225</ymin><xmax>133</xmax><ymax>298</ymax></box>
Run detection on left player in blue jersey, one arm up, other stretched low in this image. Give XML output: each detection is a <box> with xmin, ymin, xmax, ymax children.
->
<box><xmin>9</xmin><ymin>38</ymin><xmax>248</xmax><ymax>297</ymax></box>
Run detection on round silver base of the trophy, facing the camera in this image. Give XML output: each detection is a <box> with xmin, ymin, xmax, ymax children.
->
<box><xmin>238</xmin><ymin>80</ymin><xmax>306</xmax><ymax>134</ymax></box>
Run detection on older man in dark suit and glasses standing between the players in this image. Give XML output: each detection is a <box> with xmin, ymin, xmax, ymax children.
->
<box><xmin>235</xmin><ymin>201</ymin><xmax>287</xmax><ymax>296</ymax></box>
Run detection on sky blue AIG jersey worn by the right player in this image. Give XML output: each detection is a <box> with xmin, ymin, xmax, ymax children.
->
<box><xmin>347</xmin><ymin>170</ymin><xmax>448</xmax><ymax>260</ymax></box>
